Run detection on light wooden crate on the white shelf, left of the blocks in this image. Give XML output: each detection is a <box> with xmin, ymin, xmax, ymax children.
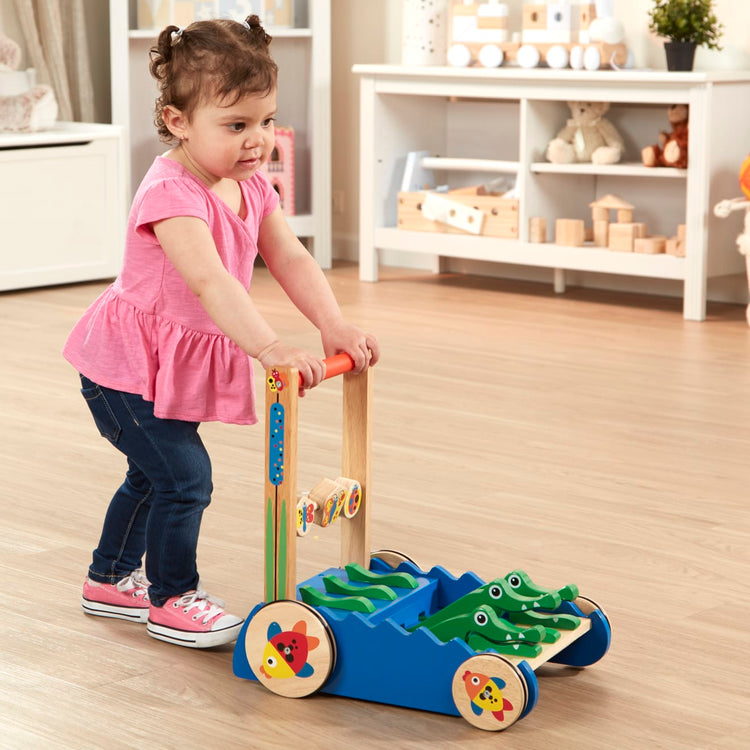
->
<box><xmin>398</xmin><ymin>190</ymin><xmax>518</xmax><ymax>239</ymax></box>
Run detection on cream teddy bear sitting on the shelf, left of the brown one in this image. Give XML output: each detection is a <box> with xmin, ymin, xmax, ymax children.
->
<box><xmin>547</xmin><ymin>102</ymin><xmax>624</xmax><ymax>164</ymax></box>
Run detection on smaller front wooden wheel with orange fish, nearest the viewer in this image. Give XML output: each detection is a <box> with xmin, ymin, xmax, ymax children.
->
<box><xmin>451</xmin><ymin>652</ymin><xmax>528</xmax><ymax>732</ymax></box>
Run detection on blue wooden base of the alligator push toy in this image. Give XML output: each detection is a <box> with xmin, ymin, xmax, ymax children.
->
<box><xmin>234</xmin><ymin>558</ymin><xmax>611</xmax><ymax>716</ymax></box>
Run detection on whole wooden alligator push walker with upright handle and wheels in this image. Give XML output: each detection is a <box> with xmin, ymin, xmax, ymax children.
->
<box><xmin>234</xmin><ymin>354</ymin><xmax>611</xmax><ymax>731</ymax></box>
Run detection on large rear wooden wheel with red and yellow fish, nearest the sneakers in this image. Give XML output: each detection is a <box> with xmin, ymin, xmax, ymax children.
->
<box><xmin>245</xmin><ymin>599</ymin><xmax>336</xmax><ymax>698</ymax></box>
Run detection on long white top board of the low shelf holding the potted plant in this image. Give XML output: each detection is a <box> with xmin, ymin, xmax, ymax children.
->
<box><xmin>352</xmin><ymin>64</ymin><xmax>750</xmax><ymax>86</ymax></box>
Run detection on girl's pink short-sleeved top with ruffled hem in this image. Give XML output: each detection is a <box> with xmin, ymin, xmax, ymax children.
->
<box><xmin>63</xmin><ymin>156</ymin><xmax>279</xmax><ymax>424</ymax></box>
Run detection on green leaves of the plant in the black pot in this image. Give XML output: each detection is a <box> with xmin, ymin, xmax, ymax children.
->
<box><xmin>648</xmin><ymin>0</ymin><xmax>724</xmax><ymax>50</ymax></box>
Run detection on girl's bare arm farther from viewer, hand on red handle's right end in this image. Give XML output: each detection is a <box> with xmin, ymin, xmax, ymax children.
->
<box><xmin>258</xmin><ymin>207</ymin><xmax>380</xmax><ymax>372</ymax></box>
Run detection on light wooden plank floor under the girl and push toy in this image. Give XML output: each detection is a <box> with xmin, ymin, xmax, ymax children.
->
<box><xmin>0</xmin><ymin>266</ymin><xmax>750</xmax><ymax>750</ymax></box>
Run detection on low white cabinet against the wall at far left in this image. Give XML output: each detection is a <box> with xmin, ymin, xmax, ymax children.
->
<box><xmin>0</xmin><ymin>122</ymin><xmax>125</xmax><ymax>290</ymax></box>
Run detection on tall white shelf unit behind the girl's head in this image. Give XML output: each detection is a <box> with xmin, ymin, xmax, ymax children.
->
<box><xmin>109</xmin><ymin>0</ymin><xmax>332</xmax><ymax>268</ymax></box>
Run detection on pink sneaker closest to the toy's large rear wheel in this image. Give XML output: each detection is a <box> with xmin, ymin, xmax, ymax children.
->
<box><xmin>147</xmin><ymin>589</ymin><xmax>243</xmax><ymax>648</ymax></box>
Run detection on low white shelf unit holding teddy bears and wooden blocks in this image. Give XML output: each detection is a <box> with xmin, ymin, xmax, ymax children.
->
<box><xmin>353</xmin><ymin>65</ymin><xmax>750</xmax><ymax>320</ymax></box>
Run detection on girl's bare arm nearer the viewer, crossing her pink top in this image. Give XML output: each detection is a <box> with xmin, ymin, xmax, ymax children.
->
<box><xmin>153</xmin><ymin>216</ymin><xmax>325</xmax><ymax>388</ymax></box>
